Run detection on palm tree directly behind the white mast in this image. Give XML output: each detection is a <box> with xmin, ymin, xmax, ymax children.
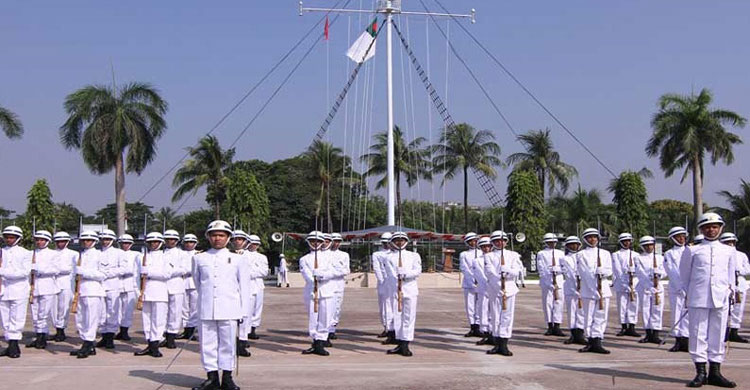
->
<box><xmin>360</xmin><ymin>126</ymin><xmax>432</xmax><ymax>220</ymax></box>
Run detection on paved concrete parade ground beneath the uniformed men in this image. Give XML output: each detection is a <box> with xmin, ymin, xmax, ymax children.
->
<box><xmin>0</xmin><ymin>286</ymin><xmax>750</xmax><ymax>390</ymax></box>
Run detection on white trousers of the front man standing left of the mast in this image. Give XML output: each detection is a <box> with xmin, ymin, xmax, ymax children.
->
<box><xmin>198</xmin><ymin>320</ymin><xmax>237</xmax><ymax>371</ymax></box>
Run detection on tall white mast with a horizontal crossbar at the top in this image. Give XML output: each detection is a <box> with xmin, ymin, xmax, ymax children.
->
<box><xmin>299</xmin><ymin>0</ymin><xmax>476</xmax><ymax>226</ymax></box>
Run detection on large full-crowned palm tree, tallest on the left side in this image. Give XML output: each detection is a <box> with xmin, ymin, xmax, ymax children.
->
<box><xmin>60</xmin><ymin>82</ymin><xmax>167</xmax><ymax>235</ymax></box>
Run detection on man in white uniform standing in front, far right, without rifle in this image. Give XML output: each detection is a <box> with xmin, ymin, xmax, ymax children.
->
<box><xmin>680</xmin><ymin>213</ymin><xmax>737</xmax><ymax>388</ymax></box>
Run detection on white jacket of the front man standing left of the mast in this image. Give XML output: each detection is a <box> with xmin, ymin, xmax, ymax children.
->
<box><xmin>193</xmin><ymin>248</ymin><xmax>250</xmax><ymax>320</ymax></box>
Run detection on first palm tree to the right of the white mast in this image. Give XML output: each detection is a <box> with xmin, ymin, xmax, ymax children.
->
<box><xmin>432</xmin><ymin>123</ymin><xmax>503</xmax><ymax>229</ymax></box>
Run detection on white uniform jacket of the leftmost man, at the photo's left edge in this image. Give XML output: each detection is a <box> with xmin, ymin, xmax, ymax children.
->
<box><xmin>0</xmin><ymin>245</ymin><xmax>31</xmax><ymax>301</ymax></box>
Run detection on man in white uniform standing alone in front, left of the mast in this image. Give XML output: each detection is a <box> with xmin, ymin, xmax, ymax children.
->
<box><xmin>192</xmin><ymin>220</ymin><xmax>249</xmax><ymax>390</ymax></box>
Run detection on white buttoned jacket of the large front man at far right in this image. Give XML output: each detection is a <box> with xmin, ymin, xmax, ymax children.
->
<box><xmin>680</xmin><ymin>240</ymin><xmax>737</xmax><ymax>309</ymax></box>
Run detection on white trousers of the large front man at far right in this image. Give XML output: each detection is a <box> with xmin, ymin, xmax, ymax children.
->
<box><xmin>688</xmin><ymin>305</ymin><xmax>729</xmax><ymax>363</ymax></box>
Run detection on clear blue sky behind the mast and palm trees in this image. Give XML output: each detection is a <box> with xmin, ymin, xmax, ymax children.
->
<box><xmin>0</xmin><ymin>0</ymin><xmax>750</xmax><ymax>213</ymax></box>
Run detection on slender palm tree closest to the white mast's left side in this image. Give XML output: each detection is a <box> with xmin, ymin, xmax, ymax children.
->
<box><xmin>305</xmin><ymin>141</ymin><xmax>351</xmax><ymax>232</ymax></box>
